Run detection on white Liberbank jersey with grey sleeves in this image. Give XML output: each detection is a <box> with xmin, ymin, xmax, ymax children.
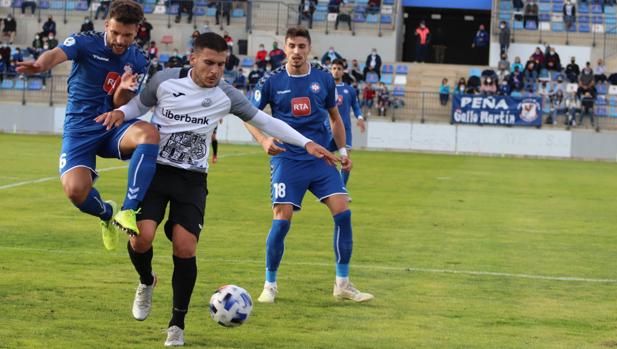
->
<box><xmin>140</xmin><ymin>68</ymin><xmax>258</xmax><ymax>172</ymax></box>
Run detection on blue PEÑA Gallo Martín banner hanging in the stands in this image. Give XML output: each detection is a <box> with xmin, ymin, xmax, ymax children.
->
<box><xmin>452</xmin><ymin>95</ymin><xmax>542</xmax><ymax>127</ymax></box>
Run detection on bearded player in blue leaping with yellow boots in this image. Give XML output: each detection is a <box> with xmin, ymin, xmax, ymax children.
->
<box><xmin>18</xmin><ymin>0</ymin><xmax>159</xmax><ymax>249</ymax></box>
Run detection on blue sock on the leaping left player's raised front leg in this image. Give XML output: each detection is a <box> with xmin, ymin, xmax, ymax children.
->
<box><xmin>122</xmin><ymin>144</ymin><xmax>159</xmax><ymax>210</ymax></box>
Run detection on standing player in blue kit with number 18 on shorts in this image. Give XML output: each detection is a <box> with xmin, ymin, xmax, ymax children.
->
<box><xmin>246</xmin><ymin>27</ymin><xmax>373</xmax><ymax>303</ymax></box>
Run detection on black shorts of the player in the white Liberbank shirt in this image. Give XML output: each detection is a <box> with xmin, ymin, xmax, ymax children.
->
<box><xmin>137</xmin><ymin>164</ymin><xmax>208</xmax><ymax>240</ymax></box>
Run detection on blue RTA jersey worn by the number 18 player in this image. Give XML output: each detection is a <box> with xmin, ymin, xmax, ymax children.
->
<box><xmin>252</xmin><ymin>64</ymin><xmax>337</xmax><ymax>160</ymax></box>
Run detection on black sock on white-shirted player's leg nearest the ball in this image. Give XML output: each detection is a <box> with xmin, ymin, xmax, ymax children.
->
<box><xmin>169</xmin><ymin>256</ymin><xmax>197</xmax><ymax>329</ymax></box>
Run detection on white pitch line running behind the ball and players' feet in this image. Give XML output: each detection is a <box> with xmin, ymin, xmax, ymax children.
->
<box><xmin>0</xmin><ymin>246</ymin><xmax>617</xmax><ymax>284</ymax></box>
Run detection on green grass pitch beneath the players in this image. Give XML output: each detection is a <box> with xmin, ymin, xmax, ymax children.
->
<box><xmin>0</xmin><ymin>135</ymin><xmax>617</xmax><ymax>348</ymax></box>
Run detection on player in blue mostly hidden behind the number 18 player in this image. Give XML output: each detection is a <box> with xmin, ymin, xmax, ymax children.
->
<box><xmin>324</xmin><ymin>58</ymin><xmax>366</xmax><ymax>197</ymax></box>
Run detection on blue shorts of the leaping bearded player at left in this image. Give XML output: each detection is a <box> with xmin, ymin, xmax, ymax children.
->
<box><xmin>60</xmin><ymin>119</ymin><xmax>139</xmax><ymax>179</ymax></box>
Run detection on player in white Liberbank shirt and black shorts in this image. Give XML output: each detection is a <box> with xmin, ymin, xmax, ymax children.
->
<box><xmin>96</xmin><ymin>32</ymin><xmax>338</xmax><ymax>346</ymax></box>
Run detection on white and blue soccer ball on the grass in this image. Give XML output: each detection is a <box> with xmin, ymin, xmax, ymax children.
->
<box><xmin>210</xmin><ymin>285</ymin><xmax>253</xmax><ymax>327</ymax></box>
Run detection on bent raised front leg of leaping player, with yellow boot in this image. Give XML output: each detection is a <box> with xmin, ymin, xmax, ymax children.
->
<box><xmin>107</xmin><ymin>121</ymin><xmax>159</xmax><ymax>234</ymax></box>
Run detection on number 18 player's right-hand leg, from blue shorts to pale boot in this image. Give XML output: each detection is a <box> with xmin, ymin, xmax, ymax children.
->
<box><xmin>309</xmin><ymin>161</ymin><xmax>373</xmax><ymax>302</ymax></box>
